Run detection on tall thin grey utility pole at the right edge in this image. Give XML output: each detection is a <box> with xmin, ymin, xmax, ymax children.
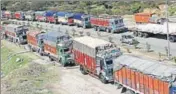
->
<box><xmin>166</xmin><ymin>0</ymin><xmax>170</xmax><ymax>60</ymax></box>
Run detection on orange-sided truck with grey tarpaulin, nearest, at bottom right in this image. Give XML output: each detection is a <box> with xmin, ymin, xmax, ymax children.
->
<box><xmin>113</xmin><ymin>54</ymin><xmax>176</xmax><ymax>94</ymax></box>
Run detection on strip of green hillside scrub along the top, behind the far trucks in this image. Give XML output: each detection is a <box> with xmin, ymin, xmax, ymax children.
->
<box><xmin>2</xmin><ymin>0</ymin><xmax>176</xmax><ymax>16</ymax></box>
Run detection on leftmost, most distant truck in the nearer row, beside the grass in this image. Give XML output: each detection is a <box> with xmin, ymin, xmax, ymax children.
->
<box><xmin>5</xmin><ymin>24</ymin><xmax>28</xmax><ymax>44</ymax></box>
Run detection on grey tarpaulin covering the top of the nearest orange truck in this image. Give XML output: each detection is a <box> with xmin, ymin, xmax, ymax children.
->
<box><xmin>114</xmin><ymin>55</ymin><xmax>176</xmax><ymax>82</ymax></box>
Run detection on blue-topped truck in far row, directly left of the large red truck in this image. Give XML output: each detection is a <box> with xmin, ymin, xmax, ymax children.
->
<box><xmin>73</xmin><ymin>13</ymin><xmax>91</xmax><ymax>28</ymax></box>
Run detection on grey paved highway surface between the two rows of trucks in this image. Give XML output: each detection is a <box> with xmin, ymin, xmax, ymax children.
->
<box><xmin>9</xmin><ymin>19</ymin><xmax>176</xmax><ymax>56</ymax></box>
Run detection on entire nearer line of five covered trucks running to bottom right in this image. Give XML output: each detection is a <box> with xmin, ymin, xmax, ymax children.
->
<box><xmin>1</xmin><ymin>21</ymin><xmax>176</xmax><ymax>94</ymax></box>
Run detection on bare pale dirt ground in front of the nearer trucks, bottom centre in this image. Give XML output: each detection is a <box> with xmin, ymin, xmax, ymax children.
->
<box><xmin>46</xmin><ymin>66</ymin><xmax>121</xmax><ymax>94</ymax></box>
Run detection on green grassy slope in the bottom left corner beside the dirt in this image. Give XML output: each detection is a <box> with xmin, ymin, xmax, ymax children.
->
<box><xmin>1</xmin><ymin>40</ymin><xmax>58</xmax><ymax>94</ymax></box>
